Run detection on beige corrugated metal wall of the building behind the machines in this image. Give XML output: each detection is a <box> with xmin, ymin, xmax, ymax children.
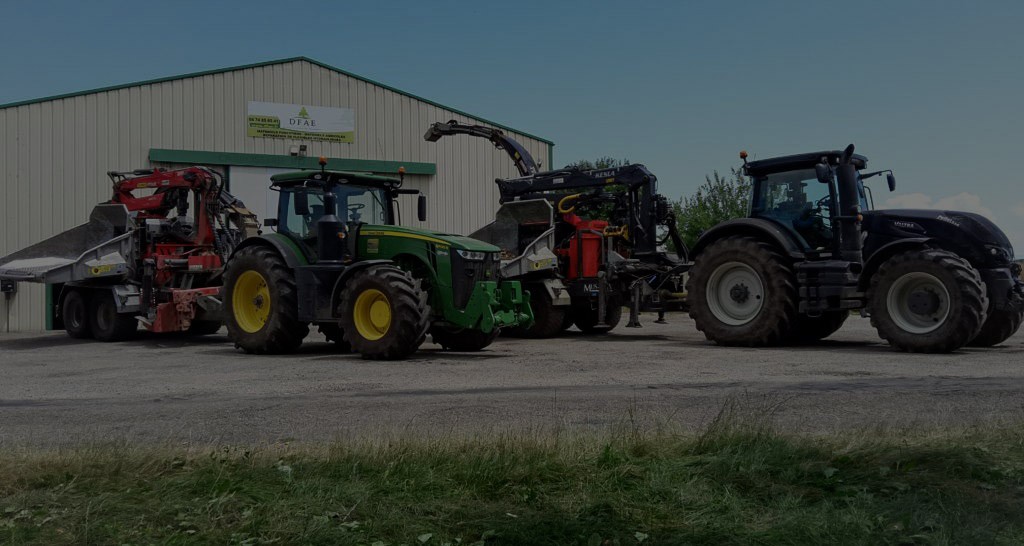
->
<box><xmin>0</xmin><ymin>60</ymin><xmax>549</xmax><ymax>332</ymax></box>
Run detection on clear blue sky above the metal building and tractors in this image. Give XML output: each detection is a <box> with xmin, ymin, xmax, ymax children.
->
<box><xmin>0</xmin><ymin>1</ymin><xmax>1024</xmax><ymax>246</ymax></box>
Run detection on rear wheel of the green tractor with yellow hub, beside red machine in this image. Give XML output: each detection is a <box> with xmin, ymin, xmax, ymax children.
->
<box><xmin>224</xmin><ymin>246</ymin><xmax>309</xmax><ymax>354</ymax></box>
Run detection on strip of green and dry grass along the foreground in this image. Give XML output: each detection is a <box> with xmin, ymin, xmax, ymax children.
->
<box><xmin>0</xmin><ymin>412</ymin><xmax>1024</xmax><ymax>545</ymax></box>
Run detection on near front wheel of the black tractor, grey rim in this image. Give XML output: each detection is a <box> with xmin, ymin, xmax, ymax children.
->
<box><xmin>867</xmin><ymin>249</ymin><xmax>988</xmax><ymax>352</ymax></box>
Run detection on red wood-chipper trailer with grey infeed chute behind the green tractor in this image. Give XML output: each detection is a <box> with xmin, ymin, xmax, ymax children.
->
<box><xmin>0</xmin><ymin>167</ymin><xmax>258</xmax><ymax>341</ymax></box>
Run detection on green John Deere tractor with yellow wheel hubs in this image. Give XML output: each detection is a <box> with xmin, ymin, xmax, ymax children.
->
<box><xmin>223</xmin><ymin>160</ymin><xmax>534</xmax><ymax>360</ymax></box>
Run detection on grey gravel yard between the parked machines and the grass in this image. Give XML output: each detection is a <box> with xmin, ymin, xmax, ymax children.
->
<box><xmin>0</xmin><ymin>314</ymin><xmax>1024</xmax><ymax>447</ymax></box>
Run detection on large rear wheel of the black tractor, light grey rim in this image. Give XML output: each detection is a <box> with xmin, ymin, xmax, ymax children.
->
<box><xmin>686</xmin><ymin>237</ymin><xmax>797</xmax><ymax>347</ymax></box>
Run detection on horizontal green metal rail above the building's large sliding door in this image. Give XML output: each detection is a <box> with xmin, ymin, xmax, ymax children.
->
<box><xmin>150</xmin><ymin>148</ymin><xmax>437</xmax><ymax>175</ymax></box>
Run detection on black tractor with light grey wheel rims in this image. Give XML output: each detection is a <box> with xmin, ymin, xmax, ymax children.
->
<box><xmin>687</xmin><ymin>144</ymin><xmax>1024</xmax><ymax>352</ymax></box>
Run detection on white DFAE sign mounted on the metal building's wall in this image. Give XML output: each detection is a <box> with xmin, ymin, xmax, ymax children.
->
<box><xmin>246</xmin><ymin>101</ymin><xmax>355</xmax><ymax>142</ymax></box>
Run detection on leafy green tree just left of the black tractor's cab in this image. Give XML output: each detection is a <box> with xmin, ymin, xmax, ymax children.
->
<box><xmin>673</xmin><ymin>168</ymin><xmax>751</xmax><ymax>248</ymax></box>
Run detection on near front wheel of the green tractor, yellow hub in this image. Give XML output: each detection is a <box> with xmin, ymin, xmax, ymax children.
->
<box><xmin>338</xmin><ymin>265</ymin><xmax>430</xmax><ymax>361</ymax></box>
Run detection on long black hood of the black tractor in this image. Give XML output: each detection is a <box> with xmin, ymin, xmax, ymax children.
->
<box><xmin>863</xmin><ymin>209</ymin><xmax>1014</xmax><ymax>261</ymax></box>
